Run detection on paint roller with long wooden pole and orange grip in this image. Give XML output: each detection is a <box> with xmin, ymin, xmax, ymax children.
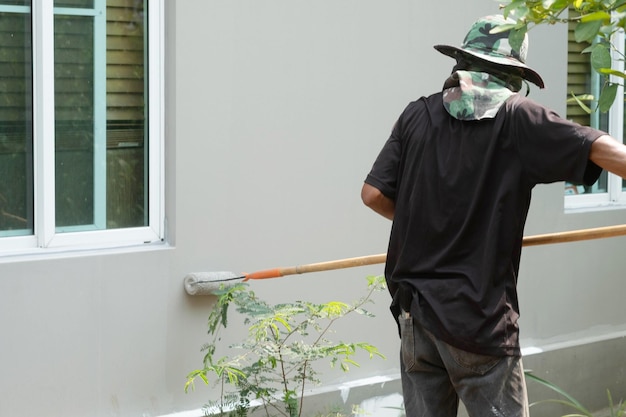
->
<box><xmin>184</xmin><ymin>224</ymin><xmax>626</xmax><ymax>295</ymax></box>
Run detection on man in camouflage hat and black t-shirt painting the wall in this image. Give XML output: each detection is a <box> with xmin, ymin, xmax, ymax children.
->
<box><xmin>361</xmin><ymin>16</ymin><xmax>626</xmax><ymax>417</ymax></box>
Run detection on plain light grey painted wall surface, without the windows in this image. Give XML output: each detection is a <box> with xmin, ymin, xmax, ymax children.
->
<box><xmin>0</xmin><ymin>0</ymin><xmax>626</xmax><ymax>417</ymax></box>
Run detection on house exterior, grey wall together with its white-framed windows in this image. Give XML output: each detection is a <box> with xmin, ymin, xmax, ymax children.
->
<box><xmin>0</xmin><ymin>0</ymin><xmax>626</xmax><ymax>417</ymax></box>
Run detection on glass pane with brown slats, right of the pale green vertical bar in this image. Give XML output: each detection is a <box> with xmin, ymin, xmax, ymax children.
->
<box><xmin>106</xmin><ymin>0</ymin><xmax>148</xmax><ymax>228</ymax></box>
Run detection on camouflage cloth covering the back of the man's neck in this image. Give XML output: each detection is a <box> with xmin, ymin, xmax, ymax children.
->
<box><xmin>443</xmin><ymin>71</ymin><xmax>515</xmax><ymax>120</ymax></box>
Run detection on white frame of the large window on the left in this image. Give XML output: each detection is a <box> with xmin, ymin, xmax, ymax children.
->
<box><xmin>0</xmin><ymin>0</ymin><xmax>165</xmax><ymax>257</ymax></box>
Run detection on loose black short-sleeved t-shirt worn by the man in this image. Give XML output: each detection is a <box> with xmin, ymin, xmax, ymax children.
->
<box><xmin>365</xmin><ymin>93</ymin><xmax>603</xmax><ymax>355</ymax></box>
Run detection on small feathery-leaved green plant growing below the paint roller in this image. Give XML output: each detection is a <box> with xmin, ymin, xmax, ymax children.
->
<box><xmin>185</xmin><ymin>276</ymin><xmax>385</xmax><ymax>417</ymax></box>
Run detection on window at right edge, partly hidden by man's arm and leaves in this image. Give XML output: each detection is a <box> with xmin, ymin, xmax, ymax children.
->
<box><xmin>565</xmin><ymin>16</ymin><xmax>626</xmax><ymax>210</ymax></box>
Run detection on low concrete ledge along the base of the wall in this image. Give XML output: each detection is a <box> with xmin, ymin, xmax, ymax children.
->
<box><xmin>163</xmin><ymin>335</ymin><xmax>626</xmax><ymax>417</ymax></box>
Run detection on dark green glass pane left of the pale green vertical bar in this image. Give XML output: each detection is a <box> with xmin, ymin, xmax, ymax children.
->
<box><xmin>54</xmin><ymin>15</ymin><xmax>97</xmax><ymax>227</ymax></box>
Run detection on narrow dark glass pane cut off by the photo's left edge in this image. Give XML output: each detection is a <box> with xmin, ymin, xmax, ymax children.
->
<box><xmin>0</xmin><ymin>8</ymin><xmax>33</xmax><ymax>237</ymax></box>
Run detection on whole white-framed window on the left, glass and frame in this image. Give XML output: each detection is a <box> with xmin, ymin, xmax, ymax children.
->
<box><xmin>0</xmin><ymin>0</ymin><xmax>163</xmax><ymax>253</ymax></box>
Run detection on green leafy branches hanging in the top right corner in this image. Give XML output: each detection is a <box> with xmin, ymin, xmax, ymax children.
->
<box><xmin>502</xmin><ymin>0</ymin><xmax>626</xmax><ymax>112</ymax></box>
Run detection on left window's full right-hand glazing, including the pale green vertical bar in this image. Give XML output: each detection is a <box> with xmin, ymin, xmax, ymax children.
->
<box><xmin>55</xmin><ymin>0</ymin><xmax>148</xmax><ymax>232</ymax></box>
